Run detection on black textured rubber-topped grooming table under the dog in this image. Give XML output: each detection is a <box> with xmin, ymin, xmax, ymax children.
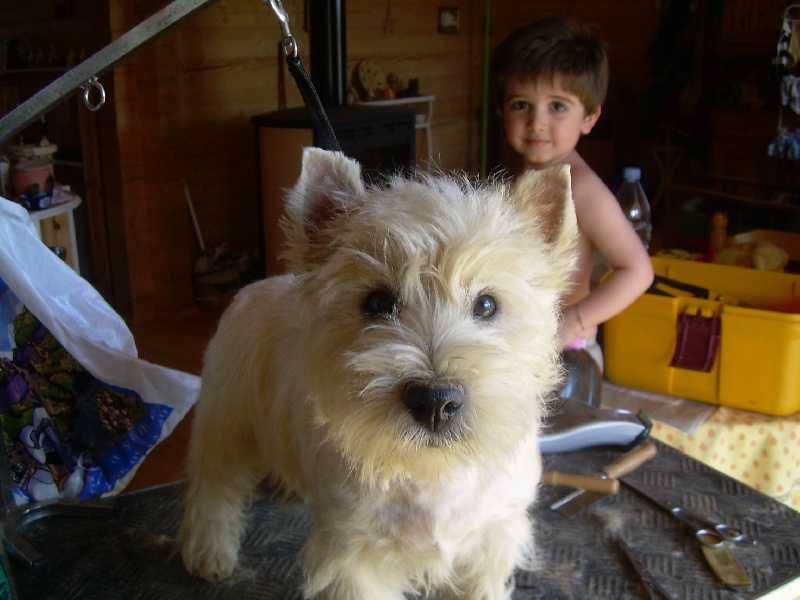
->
<box><xmin>6</xmin><ymin>442</ymin><xmax>800</xmax><ymax>600</ymax></box>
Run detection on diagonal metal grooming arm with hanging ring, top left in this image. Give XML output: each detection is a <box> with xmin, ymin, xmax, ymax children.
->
<box><xmin>0</xmin><ymin>0</ymin><xmax>222</xmax><ymax>144</ymax></box>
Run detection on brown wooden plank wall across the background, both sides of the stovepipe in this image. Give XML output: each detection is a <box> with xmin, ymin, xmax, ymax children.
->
<box><xmin>0</xmin><ymin>0</ymin><xmax>658</xmax><ymax>322</ymax></box>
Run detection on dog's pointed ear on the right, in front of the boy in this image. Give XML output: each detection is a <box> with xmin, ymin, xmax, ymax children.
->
<box><xmin>511</xmin><ymin>165</ymin><xmax>578</xmax><ymax>254</ymax></box>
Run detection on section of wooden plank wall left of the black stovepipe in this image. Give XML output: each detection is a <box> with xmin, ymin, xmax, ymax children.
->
<box><xmin>110</xmin><ymin>0</ymin><xmax>292</xmax><ymax>322</ymax></box>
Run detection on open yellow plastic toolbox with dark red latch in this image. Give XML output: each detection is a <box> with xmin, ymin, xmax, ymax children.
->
<box><xmin>603</xmin><ymin>258</ymin><xmax>800</xmax><ymax>415</ymax></box>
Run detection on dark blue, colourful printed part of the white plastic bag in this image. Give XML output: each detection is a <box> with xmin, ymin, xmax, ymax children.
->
<box><xmin>0</xmin><ymin>282</ymin><xmax>173</xmax><ymax>504</ymax></box>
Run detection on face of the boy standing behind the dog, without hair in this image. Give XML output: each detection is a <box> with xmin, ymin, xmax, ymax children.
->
<box><xmin>502</xmin><ymin>78</ymin><xmax>600</xmax><ymax>169</ymax></box>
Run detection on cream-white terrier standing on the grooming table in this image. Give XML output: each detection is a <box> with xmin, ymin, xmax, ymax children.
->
<box><xmin>179</xmin><ymin>149</ymin><xmax>577</xmax><ymax>600</ymax></box>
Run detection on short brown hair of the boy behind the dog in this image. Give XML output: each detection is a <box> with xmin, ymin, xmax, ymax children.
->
<box><xmin>491</xmin><ymin>18</ymin><xmax>608</xmax><ymax>114</ymax></box>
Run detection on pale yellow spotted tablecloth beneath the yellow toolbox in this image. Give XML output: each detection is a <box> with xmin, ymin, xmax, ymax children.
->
<box><xmin>651</xmin><ymin>407</ymin><xmax>800</xmax><ymax>511</ymax></box>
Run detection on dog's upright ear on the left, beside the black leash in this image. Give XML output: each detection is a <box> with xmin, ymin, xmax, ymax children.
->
<box><xmin>281</xmin><ymin>148</ymin><xmax>364</xmax><ymax>272</ymax></box>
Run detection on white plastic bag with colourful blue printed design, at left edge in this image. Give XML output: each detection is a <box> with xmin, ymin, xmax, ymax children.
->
<box><xmin>0</xmin><ymin>198</ymin><xmax>200</xmax><ymax>505</ymax></box>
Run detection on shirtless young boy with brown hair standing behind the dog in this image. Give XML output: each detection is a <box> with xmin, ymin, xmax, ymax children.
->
<box><xmin>492</xmin><ymin>19</ymin><xmax>653</xmax><ymax>369</ymax></box>
